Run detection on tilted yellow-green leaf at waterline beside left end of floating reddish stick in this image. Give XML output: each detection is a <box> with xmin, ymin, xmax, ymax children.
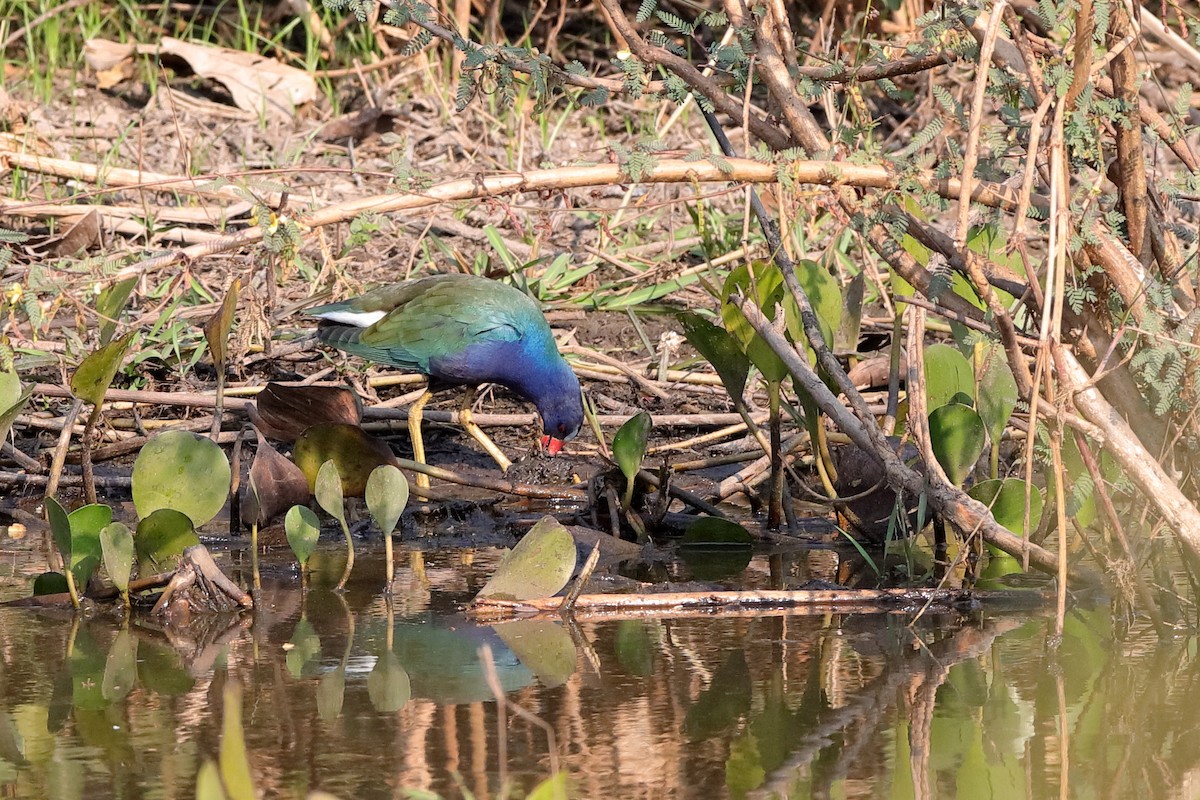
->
<box><xmin>479</xmin><ymin>515</ymin><xmax>576</xmax><ymax>600</ymax></box>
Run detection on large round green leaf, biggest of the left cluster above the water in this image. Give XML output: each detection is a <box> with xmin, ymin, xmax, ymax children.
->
<box><xmin>133</xmin><ymin>431</ymin><xmax>233</xmax><ymax>528</ymax></box>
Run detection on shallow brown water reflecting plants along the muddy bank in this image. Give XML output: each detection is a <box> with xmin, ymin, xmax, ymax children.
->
<box><xmin>0</xmin><ymin>532</ymin><xmax>1200</xmax><ymax>800</ymax></box>
